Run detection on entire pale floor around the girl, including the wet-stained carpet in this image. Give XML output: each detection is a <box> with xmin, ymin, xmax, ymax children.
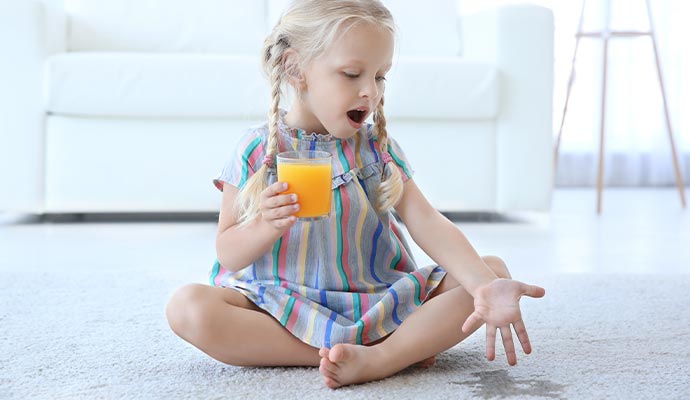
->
<box><xmin>0</xmin><ymin>189</ymin><xmax>690</xmax><ymax>400</ymax></box>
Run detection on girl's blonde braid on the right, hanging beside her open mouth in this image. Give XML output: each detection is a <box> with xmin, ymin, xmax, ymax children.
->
<box><xmin>374</xmin><ymin>97</ymin><xmax>403</xmax><ymax>212</ymax></box>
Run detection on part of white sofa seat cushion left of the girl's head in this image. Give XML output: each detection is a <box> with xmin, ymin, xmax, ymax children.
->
<box><xmin>45</xmin><ymin>53</ymin><xmax>269</xmax><ymax>117</ymax></box>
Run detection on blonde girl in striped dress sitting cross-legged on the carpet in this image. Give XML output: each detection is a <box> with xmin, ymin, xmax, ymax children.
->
<box><xmin>167</xmin><ymin>0</ymin><xmax>544</xmax><ymax>388</ymax></box>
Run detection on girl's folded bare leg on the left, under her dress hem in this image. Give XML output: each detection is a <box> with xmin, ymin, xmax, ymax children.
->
<box><xmin>166</xmin><ymin>284</ymin><xmax>320</xmax><ymax>366</ymax></box>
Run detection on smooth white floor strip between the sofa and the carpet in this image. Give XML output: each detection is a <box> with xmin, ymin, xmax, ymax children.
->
<box><xmin>0</xmin><ymin>189</ymin><xmax>690</xmax><ymax>281</ymax></box>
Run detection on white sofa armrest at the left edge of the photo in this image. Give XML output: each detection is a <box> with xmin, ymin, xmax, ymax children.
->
<box><xmin>0</xmin><ymin>0</ymin><xmax>65</xmax><ymax>213</ymax></box>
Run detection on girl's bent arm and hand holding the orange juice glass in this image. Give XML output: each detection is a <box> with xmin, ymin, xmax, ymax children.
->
<box><xmin>216</xmin><ymin>182</ymin><xmax>298</xmax><ymax>272</ymax></box>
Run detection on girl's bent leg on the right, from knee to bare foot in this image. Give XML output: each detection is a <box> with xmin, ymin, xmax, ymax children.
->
<box><xmin>319</xmin><ymin>256</ymin><xmax>510</xmax><ymax>388</ymax></box>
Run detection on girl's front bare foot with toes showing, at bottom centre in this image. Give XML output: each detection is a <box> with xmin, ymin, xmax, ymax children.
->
<box><xmin>319</xmin><ymin>344</ymin><xmax>397</xmax><ymax>389</ymax></box>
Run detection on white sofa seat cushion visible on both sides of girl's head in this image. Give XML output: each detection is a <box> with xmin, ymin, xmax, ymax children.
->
<box><xmin>45</xmin><ymin>53</ymin><xmax>500</xmax><ymax>119</ymax></box>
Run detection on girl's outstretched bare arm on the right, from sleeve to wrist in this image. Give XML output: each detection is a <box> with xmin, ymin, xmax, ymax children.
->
<box><xmin>395</xmin><ymin>179</ymin><xmax>498</xmax><ymax>297</ymax></box>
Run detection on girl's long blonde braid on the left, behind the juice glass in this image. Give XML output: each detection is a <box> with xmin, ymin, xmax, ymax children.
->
<box><xmin>236</xmin><ymin>37</ymin><xmax>289</xmax><ymax>226</ymax></box>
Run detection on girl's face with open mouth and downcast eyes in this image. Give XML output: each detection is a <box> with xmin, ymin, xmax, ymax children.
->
<box><xmin>286</xmin><ymin>23</ymin><xmax>393</xmax><ymax>139</ymax></box>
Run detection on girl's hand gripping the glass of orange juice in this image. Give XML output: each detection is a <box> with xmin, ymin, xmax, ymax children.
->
<box><xmin>259</xmin><ymin>182</ymin><xmax>299</xmax><ymax>231</ymax></box>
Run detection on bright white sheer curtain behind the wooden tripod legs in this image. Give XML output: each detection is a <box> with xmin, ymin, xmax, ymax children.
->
<box><xmin>460</xmin><ymin>0</ymin><xmax>690</xmax><ymax>186</ymax></box>
